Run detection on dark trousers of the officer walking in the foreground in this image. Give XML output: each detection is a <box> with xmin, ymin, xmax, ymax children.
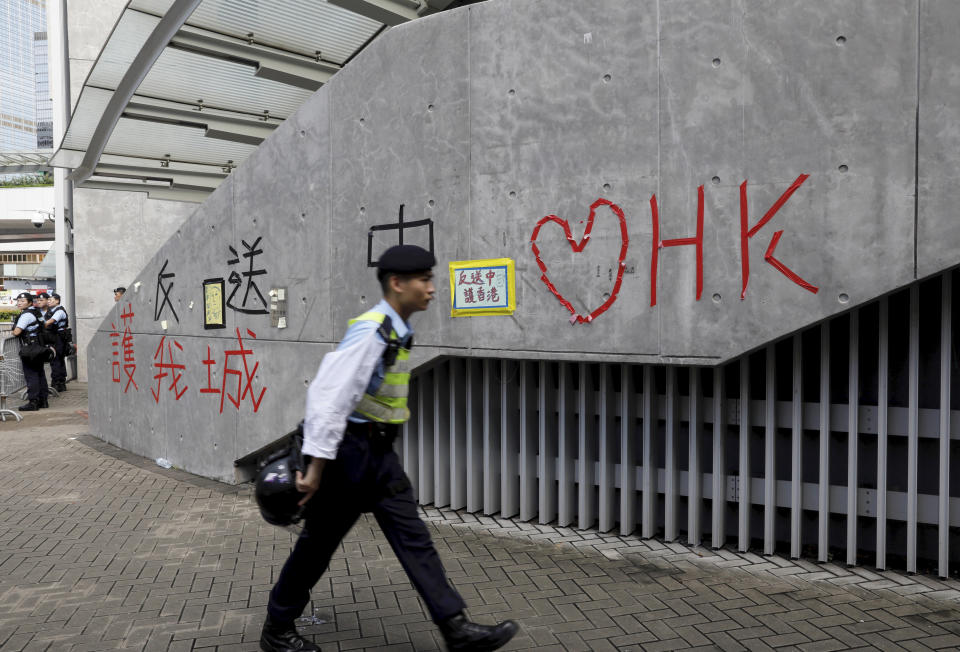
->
<box><xmin>267</xmin><ymin>423</ymin><xmax>465</xmax><ymax>624</ymax></box>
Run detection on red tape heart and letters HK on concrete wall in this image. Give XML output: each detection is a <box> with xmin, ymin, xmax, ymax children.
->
<box><xmin>530</xmin><ymin>174</ymin><xmax>819</xmax><ymax>323</ymax></box>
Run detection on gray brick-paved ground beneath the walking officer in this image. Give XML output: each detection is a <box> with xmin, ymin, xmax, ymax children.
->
<box><xmin>0</xmin><ymin>383</ymin><xmax>960</xmax><ymax>652</ymax></box>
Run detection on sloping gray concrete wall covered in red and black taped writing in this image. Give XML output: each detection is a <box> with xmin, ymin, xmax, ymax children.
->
<box><xmin>82</xmin><ymin>0</ymin><xmax>960</xmax><ymax>479</ymax></box>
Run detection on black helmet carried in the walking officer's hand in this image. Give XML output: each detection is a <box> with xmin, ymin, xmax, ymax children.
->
<box><xmin>254</xmin><ymin>431</ymin><xmax>303</xmax><ymax>526</ymax></box>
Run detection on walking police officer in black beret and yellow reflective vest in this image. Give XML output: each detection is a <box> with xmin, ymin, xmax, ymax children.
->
<box><xmin>260</xmin><ymin>245</ymin><xmax>518</xmax><ymax>652</ymax></box>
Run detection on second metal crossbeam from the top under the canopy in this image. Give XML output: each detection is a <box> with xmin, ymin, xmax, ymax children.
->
<box><xmin>170</xmin><ymin>27</ymin><xmax>340</xmax><ymax>91</ymax></box>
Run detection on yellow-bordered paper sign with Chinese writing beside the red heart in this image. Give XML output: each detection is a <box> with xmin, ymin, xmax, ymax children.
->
<box><xmin>450</xmin><ymin>258</ymin><xmax>517</xmax><ymax>317</ymax></box>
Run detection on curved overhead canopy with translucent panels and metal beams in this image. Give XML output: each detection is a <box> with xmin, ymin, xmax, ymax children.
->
<box><xmin>52</xmin><ymin>0</ymin><xmax>468</xmax><ymax>202</ymax></box>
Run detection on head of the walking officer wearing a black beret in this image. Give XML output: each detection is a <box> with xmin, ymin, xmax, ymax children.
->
<box><xmin>377</xmin><ymin>245</ymin><xmax>437</xmax><ymax>319</ymax></box>
